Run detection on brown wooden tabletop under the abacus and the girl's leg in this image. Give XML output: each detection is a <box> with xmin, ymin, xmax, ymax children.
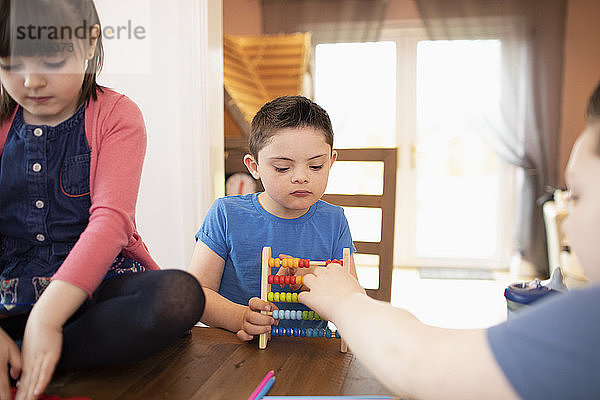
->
<box><xmin>46</xmin><ymin>327</ymin><xmax>389</xmax><ymax>400</ymax></box>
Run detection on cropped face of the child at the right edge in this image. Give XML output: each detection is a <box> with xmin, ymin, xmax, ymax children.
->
<box><xmin>564</xmin><ymin>121</ymin><xmax>600</xmax><ymax>283</ymax></box>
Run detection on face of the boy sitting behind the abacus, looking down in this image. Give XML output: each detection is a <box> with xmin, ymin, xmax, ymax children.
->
<box><xmin>244</xmin><ymin>127</ymin><xmax>337</xmax><ymax>218</ymax></box>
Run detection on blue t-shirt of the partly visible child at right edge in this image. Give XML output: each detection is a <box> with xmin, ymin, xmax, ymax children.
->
<box><xmin>487</xmin><ymin>286</ymin><xmax>600</xmax><ymax>399</ymax></box>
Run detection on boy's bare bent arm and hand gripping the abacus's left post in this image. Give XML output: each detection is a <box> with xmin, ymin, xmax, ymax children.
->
<box><xmin>188</xmin><ymin>240</ymin><xmax>275</xmax><ymax>341</ymax></box>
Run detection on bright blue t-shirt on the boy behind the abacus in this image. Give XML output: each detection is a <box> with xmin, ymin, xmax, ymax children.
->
<box><xmin>196</xmin><ymin>193</ymin><xmax>354</xmax><ymax>305</ymax></box>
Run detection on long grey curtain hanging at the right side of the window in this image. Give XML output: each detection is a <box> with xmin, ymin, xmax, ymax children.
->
<box><xmin>415</xmin><ymin>0</ymin><xmax>566</xmax><ymax>276</ymax></box>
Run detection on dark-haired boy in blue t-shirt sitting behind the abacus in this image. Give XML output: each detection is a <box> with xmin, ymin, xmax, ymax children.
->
<box><xmin>189</xmin><ymin>96</ymin><xmax>356</xmax><ymax>341</ymax></box>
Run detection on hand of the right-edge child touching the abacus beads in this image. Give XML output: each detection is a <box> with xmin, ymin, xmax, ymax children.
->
<box><xmin>298</xmin><ymin>263</ymin><xmax>366</xmax><ymax>323</ymax></box>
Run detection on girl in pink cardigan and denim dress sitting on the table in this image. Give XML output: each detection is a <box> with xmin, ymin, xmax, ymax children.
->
<box><xmin>0</xmin><ymin>0</ymin><xmax>204</xmax><ymax>399</ymax></box>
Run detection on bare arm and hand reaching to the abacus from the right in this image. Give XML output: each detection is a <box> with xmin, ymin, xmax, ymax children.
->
<box><xmin>298</xmin><ymin>264</ymin><xmax>517</xmax><ymax>399</ymax></box>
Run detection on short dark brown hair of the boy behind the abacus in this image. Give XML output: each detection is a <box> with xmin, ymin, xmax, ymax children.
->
<box><xmin>248</xmin><ymin>96</ymin><xmax>333</xmax><ymax>162</ymax></box>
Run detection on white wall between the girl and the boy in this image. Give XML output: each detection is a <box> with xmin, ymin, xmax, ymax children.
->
<box><xmin>96</xmin><ymin>0</ymin><xmax>224</xmax><ymax>268</ymax></box>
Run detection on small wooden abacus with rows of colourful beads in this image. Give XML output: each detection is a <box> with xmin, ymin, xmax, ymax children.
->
<box><xmin>258</xmin><ymin>247</ymin><xmax>350</xmax><ymax>352</ymax></box>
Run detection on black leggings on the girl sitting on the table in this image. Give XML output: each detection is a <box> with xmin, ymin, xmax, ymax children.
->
<box><xmin>0</xmin><ymin>269</ymin><xmax>204</xmax><ymax>370</ymax></box>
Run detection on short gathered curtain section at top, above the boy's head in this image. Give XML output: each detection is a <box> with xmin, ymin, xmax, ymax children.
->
<box><xmin>262</xmin><ymin>0</ymin><xmax>390</xmax><ymax>44</ymax></box>
